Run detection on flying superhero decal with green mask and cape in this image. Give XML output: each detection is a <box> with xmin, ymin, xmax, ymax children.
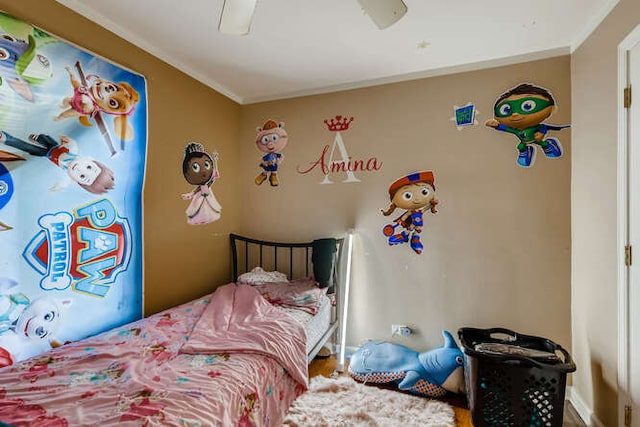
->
<box><xmin>485</xmin><ymin>83</ymin><xmax>570</xmax><ymax>168</ymax></box>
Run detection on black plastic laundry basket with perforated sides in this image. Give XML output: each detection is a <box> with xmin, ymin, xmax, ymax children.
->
<box><xmin>458</xmin><ymin>328</ymin><xmax>576</xmax><ymax>427</ymax></box>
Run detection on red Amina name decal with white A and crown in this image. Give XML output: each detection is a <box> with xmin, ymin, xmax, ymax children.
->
<box><xmin>297</xmin><ymin>115</ymin><xmax>382</xmax><ymax>184</ymax></box>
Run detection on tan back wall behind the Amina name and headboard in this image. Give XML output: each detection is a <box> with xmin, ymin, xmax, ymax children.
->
<box><xmin>240</xmin><ymin>56</ymin><xmax>571</xmax><ymax>358</ymax></box>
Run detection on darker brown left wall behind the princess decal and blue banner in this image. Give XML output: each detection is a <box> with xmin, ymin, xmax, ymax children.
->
<box><xmin>0</xmin><ymin>0</ymin><xmax>240</xmax><ymax>314</ymax></box>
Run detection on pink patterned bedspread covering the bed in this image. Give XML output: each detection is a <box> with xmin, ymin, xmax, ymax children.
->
<box><xmin>0</xmin><ymin>284</ymin><xmax>307</xmax><ymax>427</ymax></box>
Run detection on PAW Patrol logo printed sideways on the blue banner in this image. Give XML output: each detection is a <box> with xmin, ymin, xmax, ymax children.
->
<box><xmin>22</xmin><ymin>199</ymin><xmax>131</xmax><ymax>298</ymax></box>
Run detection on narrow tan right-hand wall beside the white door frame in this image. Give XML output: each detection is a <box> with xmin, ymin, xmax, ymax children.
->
<box><xmin>571</xmin><ymin>0</ymin><xmax>640</xmax><ymax>426</ymax></box>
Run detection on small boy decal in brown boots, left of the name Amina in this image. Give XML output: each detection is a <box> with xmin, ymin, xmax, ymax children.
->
<box><xmin>255</xmin><ymin>120</ymin><xmax>289</xmax><ymax>187</ymax></box>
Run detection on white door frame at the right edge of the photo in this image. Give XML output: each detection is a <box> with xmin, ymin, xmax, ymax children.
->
<box><xmin>617</xmin><ymin>25</ymin><xmax>640</xmax><ymax>426</ymax></box>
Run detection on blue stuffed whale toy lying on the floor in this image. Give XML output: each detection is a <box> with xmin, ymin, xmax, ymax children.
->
<box><xmin>349</xmin><ymin>331</ymin><xmax>465</xmax><ymax>397</ymax></box>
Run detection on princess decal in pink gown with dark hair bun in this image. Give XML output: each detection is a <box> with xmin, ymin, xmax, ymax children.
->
<box><xmin>182</xmin><ymin>142</ymin><xmax>222</xmax><ymax>225</ymax></box>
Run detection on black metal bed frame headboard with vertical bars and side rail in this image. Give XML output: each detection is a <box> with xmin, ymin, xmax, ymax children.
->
<box><xmin>229</xmin><ymin>234</ymin><xmax>345</xmax><ymax>363</ymax></box>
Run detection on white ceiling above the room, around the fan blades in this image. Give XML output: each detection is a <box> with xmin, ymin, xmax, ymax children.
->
<box><xmin>57</xmin><ymin>0</ymin><xmax>618</xmax><ymax>104</ymax></box>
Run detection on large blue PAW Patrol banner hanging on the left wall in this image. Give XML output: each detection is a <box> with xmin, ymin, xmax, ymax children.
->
<box><xmin>0</xmin><ymin>13</ymin><xmax>147</xmax><ymax>366</ymax></box>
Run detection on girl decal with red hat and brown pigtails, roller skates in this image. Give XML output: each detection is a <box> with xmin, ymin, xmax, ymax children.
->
<box><xmin>380</xmin><ymin>171</ymin><xmax>438</xmax><ymax>254</ymax></box>
